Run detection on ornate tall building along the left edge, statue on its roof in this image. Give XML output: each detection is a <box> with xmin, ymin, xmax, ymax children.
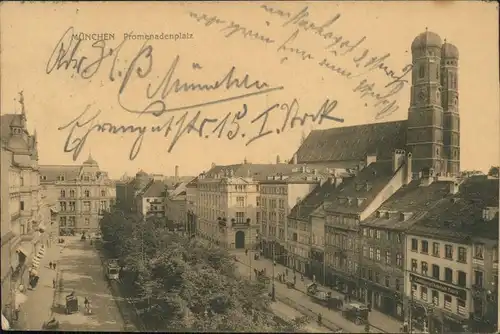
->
<box><xmin>0</xmin><ymin>107</ymin><xmax>51</xmax><ymax>328</ymax></box>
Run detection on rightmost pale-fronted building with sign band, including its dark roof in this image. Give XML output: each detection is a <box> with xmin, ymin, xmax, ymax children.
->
<box><xmin>405</xmin><ymin>177</ymin><xmax>498</xmax><ymax>332</ymax></box>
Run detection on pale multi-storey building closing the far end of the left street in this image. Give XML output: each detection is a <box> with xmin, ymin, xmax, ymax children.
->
<box><xmin>40</xmin><ymin>155</ymin><xmax>116</xmax><ymax>235</ymax></box>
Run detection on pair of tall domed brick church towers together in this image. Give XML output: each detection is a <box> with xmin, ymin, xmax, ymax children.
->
<box><xmin>406</xmin><ymin>29</ymin><xmax>460</xmax><ymax>175</ymax></box>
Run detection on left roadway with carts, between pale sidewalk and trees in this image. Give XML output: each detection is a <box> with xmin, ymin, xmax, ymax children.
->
<box><xmin>54</xmin><ymin>237</ymin><xmax>124</xmax><ymax>331</ymax></box>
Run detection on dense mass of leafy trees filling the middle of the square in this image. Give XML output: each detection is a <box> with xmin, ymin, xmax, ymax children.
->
<box><xmin>101</xmin><ymin>213</ymin><xmax>302</xmax><ymax>332</ymax></box>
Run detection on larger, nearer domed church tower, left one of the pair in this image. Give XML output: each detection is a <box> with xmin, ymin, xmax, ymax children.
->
<box><xmin>407</xmin><ymin>29</ymin><xmax>445</xmax><ymax>173</ymax></box>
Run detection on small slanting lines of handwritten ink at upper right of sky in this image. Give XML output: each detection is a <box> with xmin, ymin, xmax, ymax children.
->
<box><xmin>188</xmin><ymin>3</ymin><xmax>413</xmax><ymax>119</ymax></box>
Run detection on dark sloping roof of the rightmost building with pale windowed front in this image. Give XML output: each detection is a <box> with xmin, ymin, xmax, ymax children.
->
<box><xmin>409</xmin><ymin>176</ymin><xmax>498</xmax><ymax>242</ymax></box>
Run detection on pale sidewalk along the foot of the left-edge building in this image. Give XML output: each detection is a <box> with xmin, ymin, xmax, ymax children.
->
<box><xmin>16</xmin><ymin>242</ymin><xmax>64</xmax><ymax>330</ymax></box>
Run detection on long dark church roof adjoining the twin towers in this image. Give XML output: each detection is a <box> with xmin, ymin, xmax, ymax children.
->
<box><xmin>297</xmin><ymin>121</ymin><xmax>407</xmax><ymax>163</ymax></box>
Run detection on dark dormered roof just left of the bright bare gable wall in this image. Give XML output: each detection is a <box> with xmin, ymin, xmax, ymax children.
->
<box><xmin>325</xmin><ymin>161</ymin><xmax>398</xmax><ymax>214</ymax></box>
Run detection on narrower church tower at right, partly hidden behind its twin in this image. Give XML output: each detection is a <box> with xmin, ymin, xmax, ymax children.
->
<box><xmin>441</xmin><ymin>40</ymin><xmax>460</xmax><ymax>175</ymax></box>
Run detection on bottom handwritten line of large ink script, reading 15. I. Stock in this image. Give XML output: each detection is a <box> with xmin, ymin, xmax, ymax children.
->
<box><xmin>58</xmin><ymin>98</ymin><xmax>344</xmax><ymax>160</ymax></box>
